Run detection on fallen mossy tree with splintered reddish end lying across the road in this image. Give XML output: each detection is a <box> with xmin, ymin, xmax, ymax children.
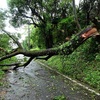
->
<box><xmin>0</xmin><ymin>22</ymin><xmax>100</xmax><ymax>69</ymax></box>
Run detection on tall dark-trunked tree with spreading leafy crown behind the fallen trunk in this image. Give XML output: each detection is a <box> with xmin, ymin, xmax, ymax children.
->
<box><xmin>8</xmin><ymin>0</ymin><xmax>70</xmax><ymax>48</ymax></box>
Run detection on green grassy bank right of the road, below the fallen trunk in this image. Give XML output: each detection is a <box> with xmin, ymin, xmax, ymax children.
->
<box><xmin>45</xmin><ymin>38</ymin><xmax>100</xmax><ymax>92</ymax></box>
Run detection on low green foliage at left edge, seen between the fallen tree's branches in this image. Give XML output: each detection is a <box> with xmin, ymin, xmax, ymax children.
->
<box><xmin>0</xmin><ymin>34</ymin><xmax>17</xmax><ymax>85</ymax></box>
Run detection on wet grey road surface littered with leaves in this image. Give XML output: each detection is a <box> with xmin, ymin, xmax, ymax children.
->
<box><xmin>1</xmin><ymin>61</ymin><xmax>100</xmax><ymax>100</ymax></box>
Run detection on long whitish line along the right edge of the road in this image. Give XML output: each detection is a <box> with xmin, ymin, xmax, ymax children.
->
<box><xmin>37</xmin><ymin>61</ymin><xmax>100</xmax><ymax>96</ymax></box>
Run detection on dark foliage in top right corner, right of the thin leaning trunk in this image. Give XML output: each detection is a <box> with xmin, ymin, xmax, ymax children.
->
<box><xmin>79</xmin><ymin>0</ymin><xmax>100</xmax><ymax>25</ymax></box>
